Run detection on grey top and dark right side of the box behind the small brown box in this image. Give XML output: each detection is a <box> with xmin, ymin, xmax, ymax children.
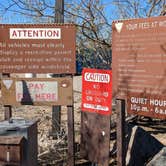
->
<box><xmin>0</xmin><ymin>119</ymin><xmax>38</xmax><ymax>166</ymax></box>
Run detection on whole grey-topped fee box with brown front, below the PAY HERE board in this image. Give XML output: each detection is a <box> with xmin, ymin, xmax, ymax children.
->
<box><xmin>0</xmin><ymin>119</ymin><xmax>38</xmax><ymax>166</ymax></box>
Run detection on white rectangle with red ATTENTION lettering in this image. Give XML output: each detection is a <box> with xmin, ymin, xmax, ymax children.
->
<box><xmin>10</xmin><ymin>28</ymin><xmax>61</xmax><ymax>39</ymax></box>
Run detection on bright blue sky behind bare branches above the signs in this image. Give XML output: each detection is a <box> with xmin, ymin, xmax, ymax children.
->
<box><xmin>0</xmin><ymin>0</ymin><xmax>164</xmax><ymax>24</ymax></box>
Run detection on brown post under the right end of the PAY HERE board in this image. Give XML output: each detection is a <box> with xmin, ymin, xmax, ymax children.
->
<box><xmin>67</xmin><ymin>106</ymin><xmax>75</xmax><ymax>166</ymax></box>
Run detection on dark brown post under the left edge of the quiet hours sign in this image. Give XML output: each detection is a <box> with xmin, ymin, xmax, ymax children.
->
<box><xmin>116</xmin><ymin>99</ymin><xmax>126</xmax><ymax>166</ymax></box>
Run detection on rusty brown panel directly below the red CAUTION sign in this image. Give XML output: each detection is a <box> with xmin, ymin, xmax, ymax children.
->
<box><xmin>81</xmin><ymin>112</ymin><xmax>110</xmax><ymax>166</ymax></box>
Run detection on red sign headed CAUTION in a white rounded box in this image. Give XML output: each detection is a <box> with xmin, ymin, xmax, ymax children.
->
<box><xmin>81</xmin><ymin>68</ymin><xmax>112</xmax><ymax>115</ymax></box>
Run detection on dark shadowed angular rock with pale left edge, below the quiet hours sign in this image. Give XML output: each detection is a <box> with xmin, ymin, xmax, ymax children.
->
<box><xmin>126</xmin><ymin>126</ymin><xmax>164</xmax><ymax>166</ymax></box>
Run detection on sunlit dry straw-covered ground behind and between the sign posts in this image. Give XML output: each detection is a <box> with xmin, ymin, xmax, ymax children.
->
<box><xmin>0</xmin><ymin>81</ymin><xmax>166</xmax><ymax>166</ymax></box>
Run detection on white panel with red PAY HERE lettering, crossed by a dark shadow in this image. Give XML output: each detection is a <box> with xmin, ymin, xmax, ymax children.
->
<box><xmin>16</xmin><ymin>81</ymin><xmax>58</xmax><ymax>102</ymax></box>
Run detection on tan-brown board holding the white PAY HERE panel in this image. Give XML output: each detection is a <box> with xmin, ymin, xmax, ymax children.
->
<box><xmin>1</xmin><ymin>77</ymin><xmax>73</xmax><ymax>105</ymax></box>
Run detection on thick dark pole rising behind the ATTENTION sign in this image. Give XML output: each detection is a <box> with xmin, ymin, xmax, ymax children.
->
<box><xmin>52</xmin><ymin>0</ymin><xmax>64</xmax><ymax>134</ymax></box>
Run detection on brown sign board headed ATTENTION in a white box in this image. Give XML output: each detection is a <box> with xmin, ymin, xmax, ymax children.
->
<box><xmin>0</xmin><ymin>24</ymin><xmax>76</xmax><ymax>74</ymax></box>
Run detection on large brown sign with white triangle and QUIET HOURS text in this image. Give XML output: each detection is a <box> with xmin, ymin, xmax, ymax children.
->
<box><xmin>112</xmin><ymin>17</ymin><xmax>166</xmax><ymax>118</ymax></box>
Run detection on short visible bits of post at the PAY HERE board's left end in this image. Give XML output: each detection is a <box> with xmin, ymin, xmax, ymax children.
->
<box><xmin>2</xmin><ymin>73</ymin><xmax>12</xmax><ymax>120</ymax></box>
